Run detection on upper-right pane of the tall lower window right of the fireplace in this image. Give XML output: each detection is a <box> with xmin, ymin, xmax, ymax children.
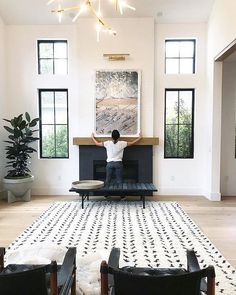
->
<box><xmin>179</xmin><ymin>91</ymin><xmax>192</xmax><ymax>124</ymax></box>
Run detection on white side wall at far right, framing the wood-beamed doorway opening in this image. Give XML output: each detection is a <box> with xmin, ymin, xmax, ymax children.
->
<box><xmin>206</xmin><ymin>0</ymin><xmax>236</xmax><ymax>200</ymax></box>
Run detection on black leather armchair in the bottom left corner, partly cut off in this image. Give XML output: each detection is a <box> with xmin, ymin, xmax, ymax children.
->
<box><xmin>0</xmin><ymin>248</ymin><xmax>76</xmax><ymax>295</ymax></box>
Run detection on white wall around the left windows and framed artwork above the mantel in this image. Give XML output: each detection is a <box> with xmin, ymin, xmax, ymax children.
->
<box><xmin>6</xmin><ymin>18</ymin><xmax>154</xmax><ymax>194</ymax></box>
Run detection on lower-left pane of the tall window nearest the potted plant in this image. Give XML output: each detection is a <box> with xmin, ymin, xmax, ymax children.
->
<box><xmin>42</xmin><ymin>125</ymin><xmax>56</xmax><ymax>158</ymax></box>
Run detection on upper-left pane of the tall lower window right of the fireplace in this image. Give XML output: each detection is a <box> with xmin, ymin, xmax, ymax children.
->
<box><xmin>166</xmin><ymin>91</ymin><xmax>178</xmax><ymax>124</ymax></box>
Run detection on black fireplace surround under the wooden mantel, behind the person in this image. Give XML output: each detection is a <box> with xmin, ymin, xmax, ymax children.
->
<box><xmin>79</xmin><ymin>145</ymin><xmax>153</xmax><ymax>183</ymax></box>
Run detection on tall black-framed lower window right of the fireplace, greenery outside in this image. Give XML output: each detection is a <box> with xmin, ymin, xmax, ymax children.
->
<box><xmin>164</xmin><ymin>89</ymin><xmax>194</xmax><ymax>158</ymax></box>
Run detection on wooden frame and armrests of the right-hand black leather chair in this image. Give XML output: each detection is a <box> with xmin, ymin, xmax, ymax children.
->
<box><xmin>100</xmin><ymin>248</ymin><xmax>215</xmax><ymax>295</ymax></box>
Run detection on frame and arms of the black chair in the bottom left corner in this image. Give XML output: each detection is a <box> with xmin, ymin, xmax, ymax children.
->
<box><xmin>0</xmin><ymin>247</ymin><xmax>76</xmax><ymax>295</ymax></box>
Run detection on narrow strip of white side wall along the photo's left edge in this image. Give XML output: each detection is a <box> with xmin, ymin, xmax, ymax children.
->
<box><xmin>0</xmin><ymin>17</ymin><xmax>6</xmax><ymax>194</ymax></box>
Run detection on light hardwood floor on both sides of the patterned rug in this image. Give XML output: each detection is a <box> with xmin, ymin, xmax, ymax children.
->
<box><xmin>0</xmin><ymin>195</ymin><xmax>236</xmax><ymax>268</ymax></box>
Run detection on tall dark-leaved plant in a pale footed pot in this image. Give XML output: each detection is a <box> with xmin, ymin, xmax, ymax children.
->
<box><xmin>3</xmin><ymin>112</ymin><xmax>39</xmax><ymax>202</ymax></box>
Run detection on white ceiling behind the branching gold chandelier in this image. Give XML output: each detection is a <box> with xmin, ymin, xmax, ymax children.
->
<box><xmin>0</xmin><ymin>0</ymin><xmax>214</xmax><ymax>25</ymax></box>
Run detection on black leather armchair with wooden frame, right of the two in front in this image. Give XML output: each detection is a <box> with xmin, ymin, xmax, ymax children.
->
<box><xmin>100</xmin><ymin>248</ymin><xmax>215</xmax><ymax>295</ymax></box>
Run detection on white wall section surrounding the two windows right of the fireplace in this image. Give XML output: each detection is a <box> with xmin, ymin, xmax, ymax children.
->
<box><xmin>154</xmin><ymin>24</ymin><xmax>207</xmax><ymax>195</ymax></box>
